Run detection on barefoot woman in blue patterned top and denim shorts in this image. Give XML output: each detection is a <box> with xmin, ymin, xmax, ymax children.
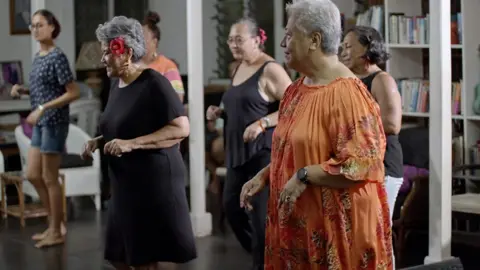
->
<box><xmin>12</xmin><ymin>9</ymin><xmax>80</xmax><ymax>248</ymax></box>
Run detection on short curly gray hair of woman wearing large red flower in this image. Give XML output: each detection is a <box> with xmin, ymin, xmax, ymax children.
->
<box><xmin>95</xmin><ymin>16</ymin><xmax>146</xmax><ymax>62</ymax></box>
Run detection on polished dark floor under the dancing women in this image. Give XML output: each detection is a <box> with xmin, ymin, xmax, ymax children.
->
<box><xmin>0</xmin><ymin>198</ymin><xmax>250</xmax><ymax>270</ymax></box>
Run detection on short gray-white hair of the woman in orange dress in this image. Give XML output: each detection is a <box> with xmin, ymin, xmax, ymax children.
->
<box><xmin>286</xmin><ymin>0</ymin><xmax>342</xmax><ymax>54</ymax></box>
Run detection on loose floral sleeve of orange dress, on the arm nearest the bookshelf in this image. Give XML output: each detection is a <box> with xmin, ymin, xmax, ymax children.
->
<box><xmin>322</xmin><ymin>77</ymin><xmax>386</xmax><ymax>182</ymax></box>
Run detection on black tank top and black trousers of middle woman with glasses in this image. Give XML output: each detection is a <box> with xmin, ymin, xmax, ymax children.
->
<box><xmin>222</xmin><ymin>61</ymin><xmax>279</xmax><ymax>270</ymax></box>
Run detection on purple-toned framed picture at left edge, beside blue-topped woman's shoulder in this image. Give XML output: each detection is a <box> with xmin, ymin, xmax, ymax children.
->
<box><xmin>0</xmin><ymin>61</ymin><xmax>23</xmax><ymax>100</ymax></box>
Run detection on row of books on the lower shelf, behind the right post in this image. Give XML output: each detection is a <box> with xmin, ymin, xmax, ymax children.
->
<box><xmin>397</xmin><ymin>79</ymin><xmax>462</xmax><ymax>115</ymax></box>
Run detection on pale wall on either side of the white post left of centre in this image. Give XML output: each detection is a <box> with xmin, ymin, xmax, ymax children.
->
<box><xmin>150</xmin><ymin>0</ymin><xmax>217</xmax><ymax>83</ymax></box>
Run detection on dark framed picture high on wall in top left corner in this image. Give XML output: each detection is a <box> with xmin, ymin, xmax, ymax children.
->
<box><xmin>10</xmin><ymin>0</ymin><xmax>31</xmax><ymax>35</ymax></box>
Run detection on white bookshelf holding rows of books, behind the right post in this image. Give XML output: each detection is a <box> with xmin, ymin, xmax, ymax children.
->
<box><xmin>383</xmin><ymin>0</ymin><xmax>480</xmax><ymax>186</ymax></box>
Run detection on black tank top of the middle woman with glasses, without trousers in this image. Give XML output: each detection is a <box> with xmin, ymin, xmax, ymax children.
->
<box><xmin>222</xmin><ymin>61</ymin><xmax>279</xmax><ymax>168</ymax></box>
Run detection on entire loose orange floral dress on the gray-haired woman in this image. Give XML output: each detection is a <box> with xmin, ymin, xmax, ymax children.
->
<box><xmin>265</xmin><ymin>78</ymin><xmax>393</xmax><ymax>270</ymax></box>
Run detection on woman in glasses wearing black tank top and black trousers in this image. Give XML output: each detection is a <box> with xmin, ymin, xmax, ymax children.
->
<box><xmin>207</xmin><ymin>19</ymin><xmax>291</xmax><ymax>269</ymax></box>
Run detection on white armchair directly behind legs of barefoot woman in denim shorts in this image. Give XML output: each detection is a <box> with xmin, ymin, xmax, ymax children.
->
<box><xmin>15</xmin><ymin>124</ymin><xmax>102</xmax><ymax>211</ymax></box>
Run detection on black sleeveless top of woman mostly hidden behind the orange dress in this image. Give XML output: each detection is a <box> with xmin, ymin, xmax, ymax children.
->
<box><xmin>362</xmin><ymin>71</ymin><xmax>403</xmax><ymax>178</ymax></box>
